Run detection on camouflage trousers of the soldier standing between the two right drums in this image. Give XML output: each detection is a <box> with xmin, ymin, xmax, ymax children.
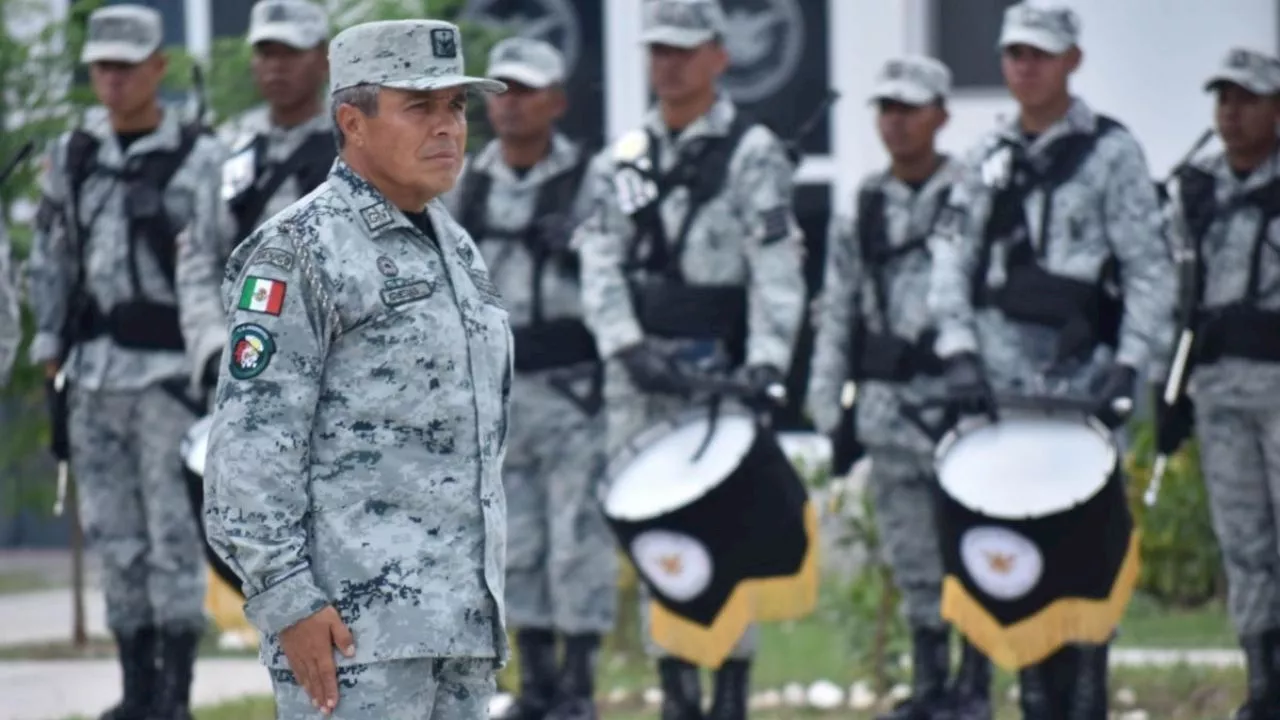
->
<box><xmin>867</xmin><ymin>446</ymin><xmax>947</xmax><ymax>630</ymax></box>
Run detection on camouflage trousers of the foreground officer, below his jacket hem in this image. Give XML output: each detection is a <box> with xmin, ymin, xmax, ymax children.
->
<box><xmin>271</xmin><ymin>657</ymin><xmax>497</xmax><ymax>720</ymax></box>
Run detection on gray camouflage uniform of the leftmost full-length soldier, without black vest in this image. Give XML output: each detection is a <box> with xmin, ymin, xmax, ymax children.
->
<box><xmin>29</xmin><ymin>103</ymin><xmax>224</xmax><ymax>634</ymax></box>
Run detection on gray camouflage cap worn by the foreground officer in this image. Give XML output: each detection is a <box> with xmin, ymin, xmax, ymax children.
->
<box><xmin>329</xmin><ymin>20</ymin><xmax>507</xmax><ymax>92</ymax></box>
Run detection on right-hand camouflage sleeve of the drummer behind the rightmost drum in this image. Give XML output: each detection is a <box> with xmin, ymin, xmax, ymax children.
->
<box><xmin>1102</xmin><ymin>133</ymin><xmax>1178</xmax><ymax>372</ymax></box>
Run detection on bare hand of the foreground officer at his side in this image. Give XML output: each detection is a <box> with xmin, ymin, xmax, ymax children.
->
<box><xmin>280</xmin><ymin>605</ymin><xmax>356</xmax><ymax>715</ymax></box>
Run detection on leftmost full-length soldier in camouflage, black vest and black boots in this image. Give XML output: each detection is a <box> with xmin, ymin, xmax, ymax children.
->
<box><xmin>31</xmin><ymin>5</ymin><xmax>224</xmax><ymax>720</ymax></box>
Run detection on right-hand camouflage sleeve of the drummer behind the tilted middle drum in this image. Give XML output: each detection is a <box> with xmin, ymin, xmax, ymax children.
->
<box><xmin>733</xmin><ymin>127</ymin><xmax>806</xmax><ymax>373</ymax></box>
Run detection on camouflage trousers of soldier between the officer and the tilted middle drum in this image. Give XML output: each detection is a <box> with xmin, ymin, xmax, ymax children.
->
<box><xmin>503</xmin><ymin>374</ymin><xmax>618</xmax><ymax>634</ymax></box>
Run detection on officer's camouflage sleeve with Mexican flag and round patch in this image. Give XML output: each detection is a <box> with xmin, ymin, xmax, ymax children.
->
<box><xmin>205</xmin><ymin>223</ymin><xmax>334</xmax><ymax>634</ymax></box>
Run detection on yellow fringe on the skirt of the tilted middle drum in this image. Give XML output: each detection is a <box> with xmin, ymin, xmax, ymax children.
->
<box><xmin>649</xmin><ymin>501</ymin><xmax>818</xmax><ymax>669</ymax></box>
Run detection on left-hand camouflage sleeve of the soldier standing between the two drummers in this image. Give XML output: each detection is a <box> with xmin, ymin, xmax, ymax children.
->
<box><xmin>805</xmin><ymin>215</ymin><xmax>861</xmax><ymax>434</ymax></box>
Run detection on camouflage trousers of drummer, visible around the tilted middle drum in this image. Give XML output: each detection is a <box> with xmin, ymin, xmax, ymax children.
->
<box><xmin>604</xmin><ymin>361</ymin><xmax>759</xmax><ymax>660</ymax></box>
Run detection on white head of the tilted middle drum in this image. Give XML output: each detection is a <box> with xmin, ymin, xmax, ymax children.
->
<box><xmin>604</xmin><ymin>414</ymin><xmax>755</xmax><ymax>521</ymax></box>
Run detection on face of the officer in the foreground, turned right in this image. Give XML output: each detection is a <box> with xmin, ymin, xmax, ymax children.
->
<box><xmin>338</xmin><ymin>87</ymin><xmax>467</xmax><ymax>202</ymax></box>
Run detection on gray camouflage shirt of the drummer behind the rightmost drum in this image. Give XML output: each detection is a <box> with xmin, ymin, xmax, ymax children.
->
<box><xmin>929</xmin><ymin>99</ymin><xmax>1176</xmax><ymax>396</ymax></box>
